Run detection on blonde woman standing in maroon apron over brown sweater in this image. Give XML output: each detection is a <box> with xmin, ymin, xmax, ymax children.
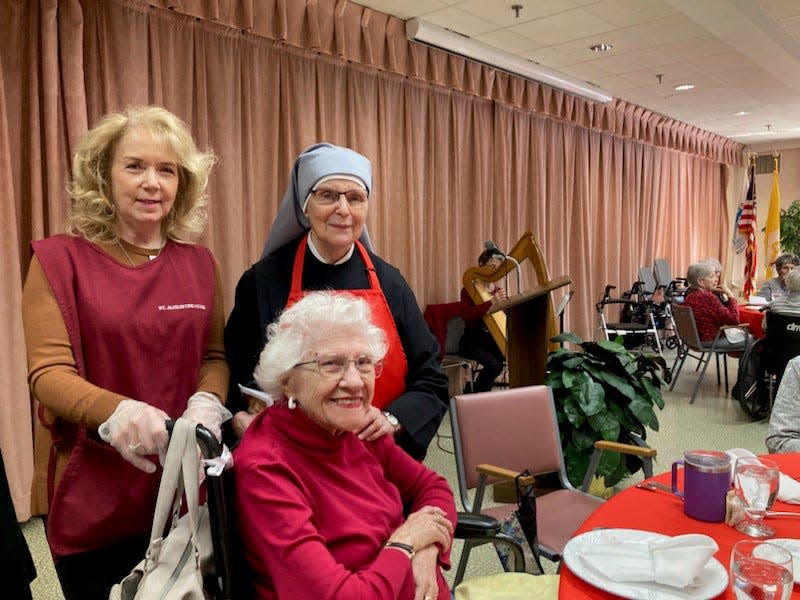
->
<box><xmin>22</xmin><ymin>107</ymin><xmax>230</xmax><ymax>600</ymax></box>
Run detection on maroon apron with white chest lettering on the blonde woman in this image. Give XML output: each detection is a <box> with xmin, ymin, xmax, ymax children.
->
<box><xmin>32</xmin><ymin>236</ymin><xmax>215</xmax><ymax>558</ymax></box>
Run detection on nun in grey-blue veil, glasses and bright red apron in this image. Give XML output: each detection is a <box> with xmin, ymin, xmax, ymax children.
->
<box><xmin>225</xmin><ymin>143</ymin><xmax>448</xmax><ymax>460</ymax></box>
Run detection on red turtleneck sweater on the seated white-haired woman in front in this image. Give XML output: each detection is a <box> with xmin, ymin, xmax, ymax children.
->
<box><xmin>234</xmin><ymin>405</ymin><xmax>456</xmax><ymax>600</ymax></box>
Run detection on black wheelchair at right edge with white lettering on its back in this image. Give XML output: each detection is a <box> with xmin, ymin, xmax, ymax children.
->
<box><xmin>732</xmin><ymin>310</ymin><xmax>800</xmax><ymax>420</ymax></box>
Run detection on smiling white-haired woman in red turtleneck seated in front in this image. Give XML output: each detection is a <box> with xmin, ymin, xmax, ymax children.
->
<box><xmin>234</xmin><ymin>292</ymin><xmax>456</xmax><ymax>600</ymax></box>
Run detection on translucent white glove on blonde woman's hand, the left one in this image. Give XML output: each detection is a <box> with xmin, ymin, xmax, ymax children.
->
<box><xmin>97</xmin><ymin>400</ymin><xmax>169</xmax><ymax>473</ymax></box>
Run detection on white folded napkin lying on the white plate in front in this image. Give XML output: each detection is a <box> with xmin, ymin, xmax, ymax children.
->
<box><xmin>580</xmin><ymin>533</ymin><xmax>719</xmax><ymax>588</ymax></box>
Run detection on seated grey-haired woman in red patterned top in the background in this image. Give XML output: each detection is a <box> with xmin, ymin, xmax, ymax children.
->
<box><xmin>683</xmin><ymin>260</ymin><xmax>743</xmax><ymax>346</ymax></box>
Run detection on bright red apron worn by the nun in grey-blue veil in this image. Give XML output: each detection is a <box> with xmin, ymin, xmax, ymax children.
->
<box><xmin>286</xmin><ymin>236</ymin><xmax>408</xmax><ymax>409</ymax></box>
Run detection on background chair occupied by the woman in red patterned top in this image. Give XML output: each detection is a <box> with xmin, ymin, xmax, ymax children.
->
<box><xmin>669</xmin><ymin>304</ymin><xmax>750</xmax><ymax>404</ymax></box>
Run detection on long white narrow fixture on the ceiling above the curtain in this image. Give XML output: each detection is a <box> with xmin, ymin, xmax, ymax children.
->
<box><xmin>406</xmin><ymin>19</ymin><xmax>613</xmax><ymax>103</ymax></box>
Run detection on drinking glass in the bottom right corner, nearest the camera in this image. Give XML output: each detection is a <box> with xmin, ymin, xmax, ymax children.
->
<box><xmin>731</xmin><ymin>540</ymin><xmax>794</xmax><ymax>600</ymax></box>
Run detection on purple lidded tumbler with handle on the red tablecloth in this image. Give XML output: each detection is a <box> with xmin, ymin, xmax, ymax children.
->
<box><xmin>672</xmin><ymin>450</ymin><xmax>731</xmax><ymax>522</ymax></box>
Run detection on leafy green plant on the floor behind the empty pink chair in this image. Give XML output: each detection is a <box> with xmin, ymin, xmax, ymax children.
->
<box><xmin>546</xmin><ymin>333</ymin><xmax>669</xmax><ymax>487</ymax></box>
